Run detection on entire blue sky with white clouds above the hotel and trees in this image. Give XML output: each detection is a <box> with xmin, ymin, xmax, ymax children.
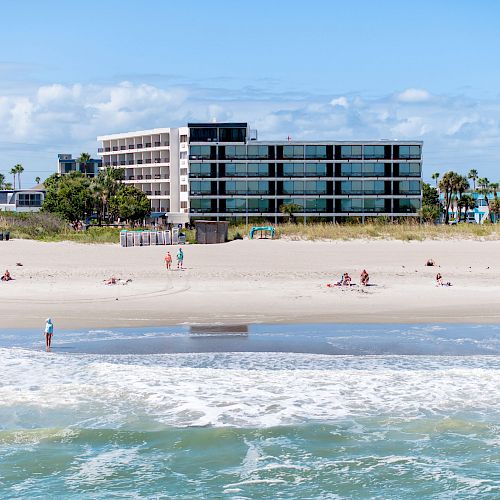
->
<box><xmin>0</xmin><ymin>0</ymin><xmax>500</xmax><ymax>187</ymax></box>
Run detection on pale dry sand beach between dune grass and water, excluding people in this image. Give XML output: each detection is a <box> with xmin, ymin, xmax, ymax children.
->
<box><xmin>0</xmin><ymin>240</ymin><xmax>500</xmax><ymax>328</ymax></box>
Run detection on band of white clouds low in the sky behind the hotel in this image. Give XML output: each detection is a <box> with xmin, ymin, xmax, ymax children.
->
<box><xmin>0</xmin><ymin>82</ymin><xmax>500</xmax><ymax>184</ymax></box>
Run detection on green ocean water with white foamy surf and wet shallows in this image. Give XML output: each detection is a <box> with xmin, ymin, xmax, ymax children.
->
<box><xmin>0</xmin><ymin>325</ymin><xmax>500</xmax><ymax>499</ymax></box>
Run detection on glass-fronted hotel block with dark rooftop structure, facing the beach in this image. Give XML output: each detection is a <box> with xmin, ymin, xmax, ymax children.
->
<box><xmin>188</xmin><ymin>123</ymin><xmax>423</xmax><ymax>222</ymax></box>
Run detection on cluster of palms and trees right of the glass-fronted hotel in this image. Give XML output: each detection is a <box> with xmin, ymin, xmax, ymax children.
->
<box><xmin>421</xmin><ymin>169</ymin><xmax>500</xmax><ymax>223</ymax></box>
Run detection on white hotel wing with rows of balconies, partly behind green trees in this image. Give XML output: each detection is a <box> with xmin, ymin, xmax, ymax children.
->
<box><xmin>98</xmin><ymin>127</ymin><xmax>189</xmax><ymax>224</ymax></box>
